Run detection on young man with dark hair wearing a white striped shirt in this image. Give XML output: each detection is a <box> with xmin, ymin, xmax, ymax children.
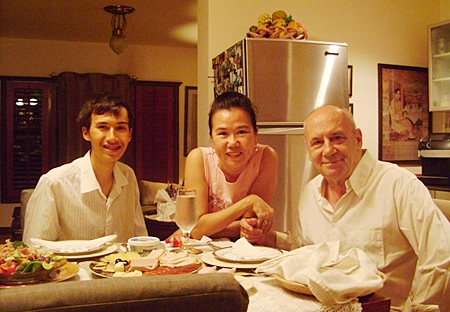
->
<box><xmin>23</xmin><ymin>94</ymin><xmax>147</xmax><ymax>244</ymax></box>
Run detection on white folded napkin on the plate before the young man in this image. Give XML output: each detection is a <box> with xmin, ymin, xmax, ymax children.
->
<box><xmin>30</xmin><ymin>234</ymin><xmax>117</xmax><ymax>253</ymax></box>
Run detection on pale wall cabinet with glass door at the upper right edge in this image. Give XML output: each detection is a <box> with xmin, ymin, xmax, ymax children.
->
<box><xmin>428</xmin><ymin>20</ymin><xmax>450</xmax><ymax>111</ymax></box>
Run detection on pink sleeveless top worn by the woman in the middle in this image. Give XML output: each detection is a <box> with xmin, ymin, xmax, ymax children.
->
<box><xmin>201</xmin><ymin>144</ymin><xmax>267</xmax><ymax>212</ymax></box>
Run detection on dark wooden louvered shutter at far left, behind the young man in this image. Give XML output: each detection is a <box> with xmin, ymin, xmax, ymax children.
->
<box><xmin>1</xmin><ymin>78</ymin><xmax>57</xmax><ymax>203</ymax></box>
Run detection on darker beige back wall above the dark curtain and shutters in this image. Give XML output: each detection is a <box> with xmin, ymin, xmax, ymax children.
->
<box><xmin>0</xmin><ymin>38</ymin><xmax>197</xmax><ymax>227</ymax></box>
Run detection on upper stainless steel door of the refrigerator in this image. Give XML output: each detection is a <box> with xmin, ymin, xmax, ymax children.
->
<box><xmin>244</xmin><ymin>38</ymin><xmax>349</xmax><ymax>122</ymax></box>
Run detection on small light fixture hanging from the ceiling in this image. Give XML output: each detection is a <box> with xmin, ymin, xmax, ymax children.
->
<box><xmin>103</xmin><ymin>5</ymin><xmax>134</xmax><ymax>54</ymax></box>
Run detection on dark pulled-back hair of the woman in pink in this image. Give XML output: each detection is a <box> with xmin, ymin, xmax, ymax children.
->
<box><xmin>208</xmin><ymin>91</ymin><xmax>258</xmax><ymax>136</ymax></box>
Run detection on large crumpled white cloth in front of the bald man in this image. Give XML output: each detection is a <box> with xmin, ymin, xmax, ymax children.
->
<box><xmin>256</xmin><ymin>241</ymin><xmax>384</xmax><ymax>305</ymax></box>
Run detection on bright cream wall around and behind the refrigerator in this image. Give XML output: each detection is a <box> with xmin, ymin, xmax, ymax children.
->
<box><xmin>198</xmin><ymin>0</ymin><xmax>442</xmax><ymax>176</ymax></box>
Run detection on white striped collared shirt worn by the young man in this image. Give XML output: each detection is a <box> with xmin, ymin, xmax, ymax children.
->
<box><xmin>23</xmin><ymin>152</ymin><xmax>147</xmax><ymax>244</ymax></box>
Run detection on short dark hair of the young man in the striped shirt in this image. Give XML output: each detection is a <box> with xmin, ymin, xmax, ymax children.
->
<box><xmin>77</xmin><ymin>93</ymin><xmax>134</xmax><ymax>129</ymax></box>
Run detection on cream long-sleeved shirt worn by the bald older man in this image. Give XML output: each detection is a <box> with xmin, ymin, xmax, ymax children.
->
<box><xmin>277</xmin><ymin>151</ymin><xmax>450</xmax><ymax>311</ymax></box>
